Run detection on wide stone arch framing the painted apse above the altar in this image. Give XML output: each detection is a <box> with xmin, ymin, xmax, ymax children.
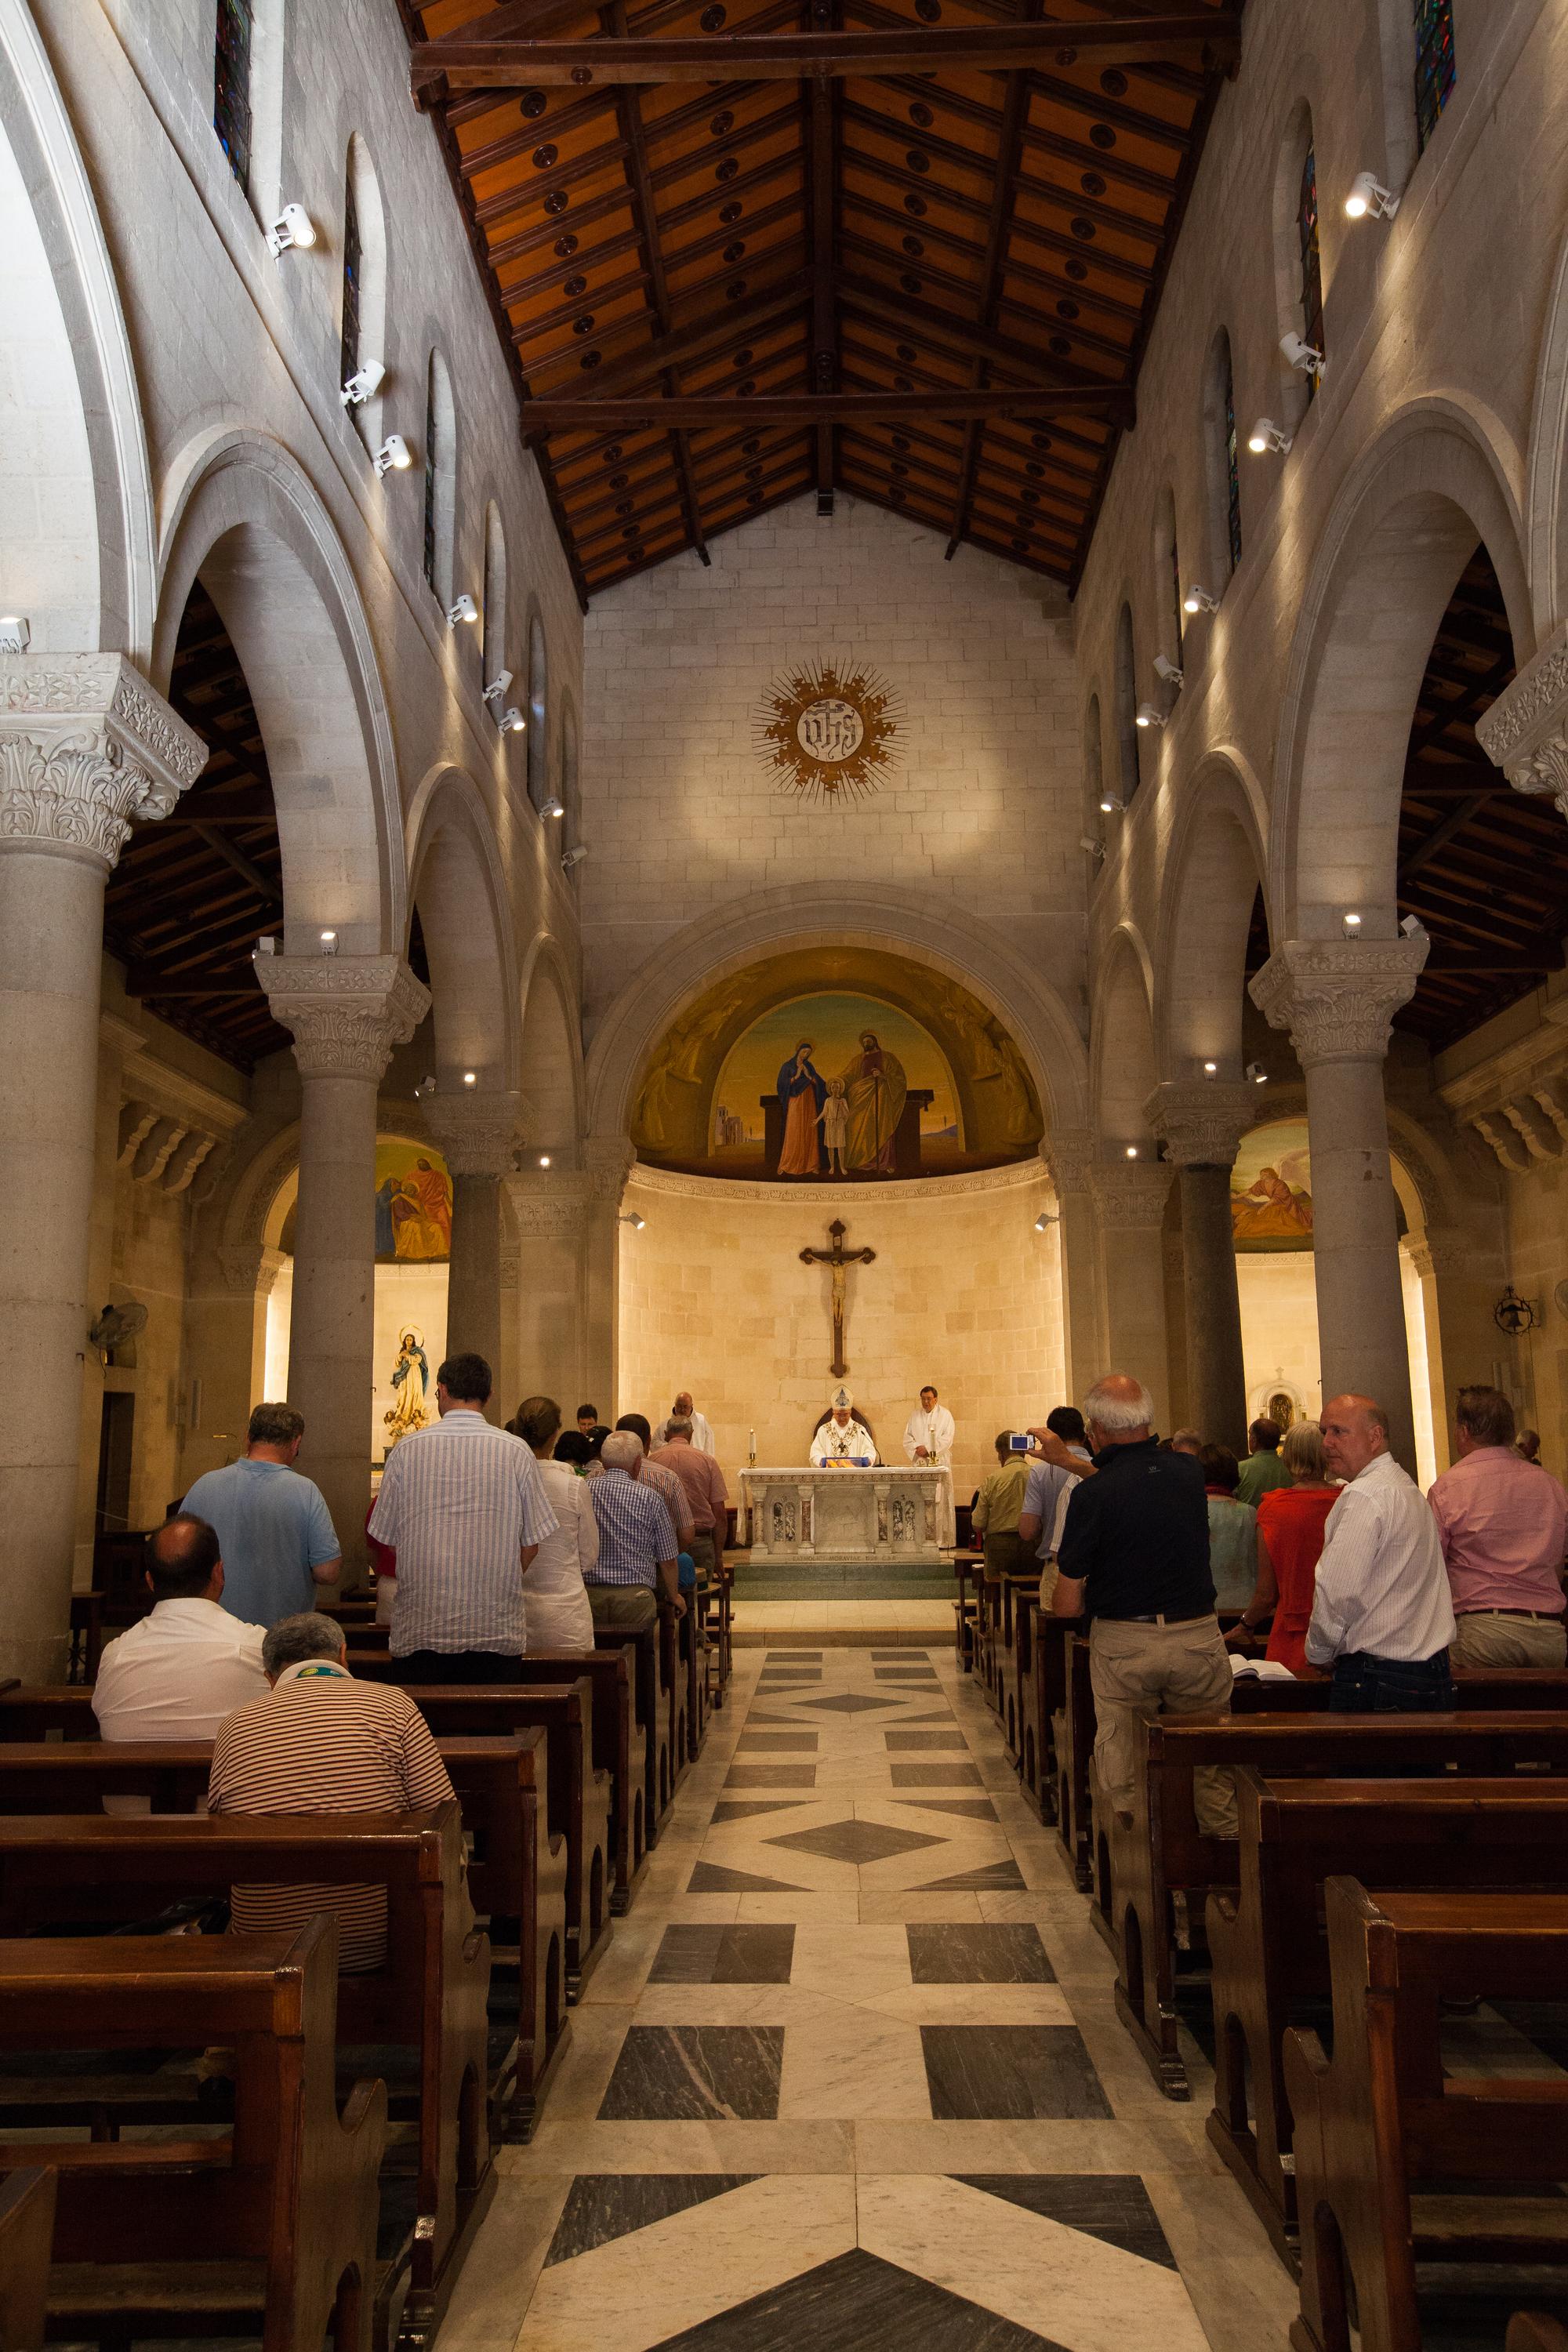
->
<box><xmin>588</xmin><ymin>889</ymin><xmax>1088</xmax><ymax>1138</ymax></box>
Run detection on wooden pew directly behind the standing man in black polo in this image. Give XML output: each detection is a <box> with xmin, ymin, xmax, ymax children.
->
<box><xmin>1095</xmin><ymin>1684</ymin><xmax>1568</xmax><ymax>2098</ymax></box>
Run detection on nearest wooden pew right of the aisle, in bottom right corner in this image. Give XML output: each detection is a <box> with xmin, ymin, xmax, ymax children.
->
<box><xmin>1286</xmin><ymin>1877</ymin><xmax>1568</xmax><ymax>2352</ymax></box>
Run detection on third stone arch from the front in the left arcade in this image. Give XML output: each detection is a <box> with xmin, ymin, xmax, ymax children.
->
<box><xmin>409</xmin><ymin>767</ymin><xmax>520</xmax><ymax>1094</ymax></box>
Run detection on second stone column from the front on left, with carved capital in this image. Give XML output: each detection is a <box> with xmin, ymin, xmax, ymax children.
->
<box><xmin>256</xmin><ymin>955</ymin><xmax>430</xmax><ymax>1588</ymax></box>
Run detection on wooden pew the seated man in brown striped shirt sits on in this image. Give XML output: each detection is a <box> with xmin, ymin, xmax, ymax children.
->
<box><xmin>0</xmin><ymin>1804</ymin><xmax>496</xmax><ymax>2347</ymax></box>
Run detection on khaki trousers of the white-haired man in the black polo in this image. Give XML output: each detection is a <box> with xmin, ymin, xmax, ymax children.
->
<box><xmin>1088</xmin><ymin>1616</ymin><xmax>1236</xmax><ymax>1837</ymax></box>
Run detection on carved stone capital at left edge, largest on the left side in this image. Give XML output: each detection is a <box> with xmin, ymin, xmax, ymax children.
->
<box><xmin>0</xmin><ymin>654</ymin><xmax>207</xmax><ymax>870</ymax></box>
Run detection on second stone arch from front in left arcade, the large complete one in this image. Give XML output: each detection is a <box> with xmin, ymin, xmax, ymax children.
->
<box><xmin>151</xmin><ymin>430</ymin><xmax>407</xmax><ymax>955</ymax></box>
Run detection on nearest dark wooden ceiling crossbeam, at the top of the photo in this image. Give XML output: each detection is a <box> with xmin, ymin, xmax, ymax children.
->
<box><xmin>409</xmin><ymin>7</ymin><xmax>1241</xmax><ymax>108</ymax></box>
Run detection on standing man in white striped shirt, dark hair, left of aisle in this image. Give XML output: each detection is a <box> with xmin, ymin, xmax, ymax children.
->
<box><xmin>369</xmin><ymin>1355</ymin><xmax>555</xmax><ymax>1682</ymax></box>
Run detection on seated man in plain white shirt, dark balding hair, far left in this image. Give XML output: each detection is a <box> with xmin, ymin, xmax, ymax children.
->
<box><xmin>92</xmin><ymin>1512</ymin><xmax>268</xmax><ymax>1740</ymax></box>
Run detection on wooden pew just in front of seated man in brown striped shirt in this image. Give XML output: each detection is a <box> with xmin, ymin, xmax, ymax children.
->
<box><xmin>0</xmin><ymin>1722</ymin><xmax>569</xmax><ymax>2140</ymax></box>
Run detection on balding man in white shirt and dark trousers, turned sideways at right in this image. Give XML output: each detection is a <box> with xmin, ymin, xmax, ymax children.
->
<box><xmin>1307</xmin><ymin>1395</ymin><xmax>1453</xmax><ymax>1715</ymax></box>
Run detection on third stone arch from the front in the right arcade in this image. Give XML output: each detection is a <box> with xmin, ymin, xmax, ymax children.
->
<box><xmin>1154</xmin><ymin>755</ymin><xmax>1267</xmax><ymax>1080</ymax></box>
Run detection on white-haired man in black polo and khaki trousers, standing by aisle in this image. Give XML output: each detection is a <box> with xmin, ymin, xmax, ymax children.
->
<box><xmin>1039</xmin><ymin>1371</ymin><xmax>1236</xmax><ymax>1837</ymax></box>
